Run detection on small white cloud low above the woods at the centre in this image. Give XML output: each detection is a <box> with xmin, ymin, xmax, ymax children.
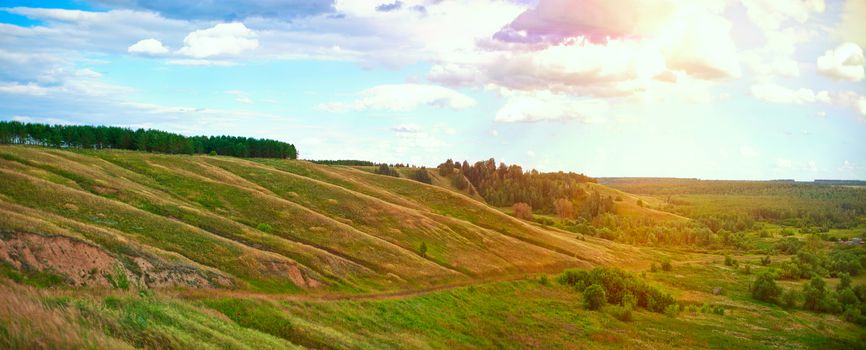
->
<box><xmin>496</xmin><ymin>92</ymin><xmax>609</xmax><ymax>123</ymax></box>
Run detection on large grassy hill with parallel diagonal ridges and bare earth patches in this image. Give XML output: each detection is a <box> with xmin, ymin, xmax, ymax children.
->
<box><xmin>0</xmin><ymin>146</ymin><xmax>648</xmax><ymax>292</ymax></box>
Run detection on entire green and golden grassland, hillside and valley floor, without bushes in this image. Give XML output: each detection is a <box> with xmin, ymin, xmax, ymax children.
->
<box><xmin>0</xmin><ymin>146</ymin><xmax>866</xmax><ymax>349</ymax></box>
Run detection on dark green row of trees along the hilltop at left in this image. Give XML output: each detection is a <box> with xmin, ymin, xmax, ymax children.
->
<box><xmin>0</xmin><ymin>121</ymin><xmax>298</xmax><ymax>159</ymax></box>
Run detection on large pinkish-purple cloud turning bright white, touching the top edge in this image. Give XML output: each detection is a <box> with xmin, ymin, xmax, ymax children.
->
<box><xmin>494</xmin><ymin>0</ymin><xmax>740</xmax><ymax>79</ymax></box>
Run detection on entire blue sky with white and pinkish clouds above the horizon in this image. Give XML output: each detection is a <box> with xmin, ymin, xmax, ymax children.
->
<box><xmin>0</xmin><ymin>0</ymin><xmax>866</xmax><ymax>180</ymax></box>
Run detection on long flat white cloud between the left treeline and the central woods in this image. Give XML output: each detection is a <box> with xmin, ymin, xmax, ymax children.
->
<box><xmin>319</xmin><ymin>84</ymin><xmax>476</xmax><ymax>112</ymax></box>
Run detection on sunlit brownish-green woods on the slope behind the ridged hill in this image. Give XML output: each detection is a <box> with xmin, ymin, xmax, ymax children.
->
<box><xmin>438</xmin><ymin>158</ymin><xmax>596</xmax><ymax>212</ymax></box>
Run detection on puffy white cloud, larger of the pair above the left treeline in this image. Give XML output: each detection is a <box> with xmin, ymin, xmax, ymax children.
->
<box><xmin>178</xmin><ymin>22</ymin><xmax>259</xmax><ymax>58</ymax></box>
